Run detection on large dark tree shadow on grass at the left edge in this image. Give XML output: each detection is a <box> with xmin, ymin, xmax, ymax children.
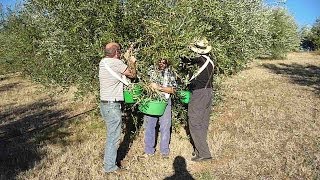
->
<box><xmin>0</xmin><ymin>100</ymin><xmax>69</xmax><ymax>180</ymax></box>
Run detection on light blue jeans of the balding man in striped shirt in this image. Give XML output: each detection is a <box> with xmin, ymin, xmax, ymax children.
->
<box><xmin>100</xmin><ymin>102</ymin><xmax>122</xmax><ymax>172</ymax></box>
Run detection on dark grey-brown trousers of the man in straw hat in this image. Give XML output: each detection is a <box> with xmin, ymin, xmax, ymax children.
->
<box><xmin>188</xmin><ymin>88</ymin><xmax>212</xmax><ymax>158</ymax></box>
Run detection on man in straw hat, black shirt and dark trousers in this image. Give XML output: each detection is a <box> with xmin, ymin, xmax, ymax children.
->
<box><xmin>184</xmin><ymin>39</ymin><xmax>214</xmax><ymax>162</ymax></box>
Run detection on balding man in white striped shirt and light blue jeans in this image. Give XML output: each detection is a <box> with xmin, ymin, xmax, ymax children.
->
<box><xmin>99</xmin><ymin>43</ymin><xmax>136</xmax><ymax>173</ymax></box>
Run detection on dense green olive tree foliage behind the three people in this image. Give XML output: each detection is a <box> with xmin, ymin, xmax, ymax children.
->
<box><xmin>0</xmin><ymin>0</ymin><xmax>298</xmax><ymax>125</ymax></box>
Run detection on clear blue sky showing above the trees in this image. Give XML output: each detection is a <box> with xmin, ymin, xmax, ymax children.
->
<box><xmin>0</xmin><ymin>0</ymin><xmax>320</xmax><ymax>28</ymax></box>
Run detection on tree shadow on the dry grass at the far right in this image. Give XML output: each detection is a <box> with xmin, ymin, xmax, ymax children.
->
<box><xmin>263</xmin><ymin>63</ymin><xmax>320</xmax><ymax>95</ymax></box>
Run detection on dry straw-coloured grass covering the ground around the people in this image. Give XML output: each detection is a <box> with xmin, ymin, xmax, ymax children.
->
<box><xmin>0</xmin><ymin>53</ymin><xmax>320</xmax><ymax>179</ymax></box>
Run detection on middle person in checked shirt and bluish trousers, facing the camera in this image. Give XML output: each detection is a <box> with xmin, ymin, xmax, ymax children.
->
<box><xmin>144</xmin><ymin>59</ymin><xmax>177</xmax><ymax>158</ymax></box>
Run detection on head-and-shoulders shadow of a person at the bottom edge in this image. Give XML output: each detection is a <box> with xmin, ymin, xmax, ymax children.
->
<box><xmin>164</xmin><ymin>156</ymin><xmax>194</xmax><ymax>180</ymax></box>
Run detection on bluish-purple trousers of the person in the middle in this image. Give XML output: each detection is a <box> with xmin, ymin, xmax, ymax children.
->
<box><xmin>144</xmin><ymin>99</ymin><xmax>171</xmax><ymax>155</ymax></box>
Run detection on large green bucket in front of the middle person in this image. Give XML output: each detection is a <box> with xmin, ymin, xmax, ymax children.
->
<box><xmin>138</xmin><ymin>100</ymin><xmax>167</xmax><ymax>116</ymax></box>
